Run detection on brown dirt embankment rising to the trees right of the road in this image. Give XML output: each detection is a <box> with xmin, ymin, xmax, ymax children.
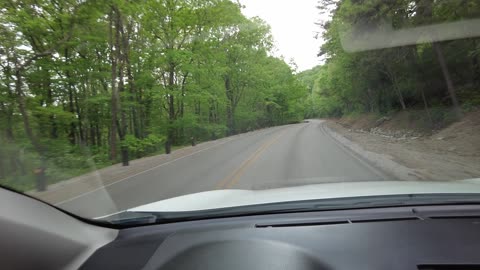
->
<box><xmin>327</xmin><ymin>111</ymin><xmax>480</xmax><ymax>180</ymax></box>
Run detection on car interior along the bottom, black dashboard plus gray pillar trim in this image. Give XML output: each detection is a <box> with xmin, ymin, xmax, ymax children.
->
<box><xmin>0</xmin><ymin>189</ymin><xmax>480</xmax><ymax>270</ymax></box>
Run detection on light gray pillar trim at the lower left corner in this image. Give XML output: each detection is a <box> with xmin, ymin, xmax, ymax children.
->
<box><xmin>0</xmin><ymin>188</ymin><xmax>118</xmax><ymax>270</ymax></box>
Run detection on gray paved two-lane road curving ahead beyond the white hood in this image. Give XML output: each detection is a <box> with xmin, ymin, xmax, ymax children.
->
<box><xmin>58</xmin><ymin>120</ymin><xmax>382</xmax><ymax>217</ymax></box>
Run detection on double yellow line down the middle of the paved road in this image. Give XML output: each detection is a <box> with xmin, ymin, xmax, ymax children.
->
<box><xmin>216</xmin><ymin>129</ymin><xmax>286</xmax><ymax>189</ymax></box>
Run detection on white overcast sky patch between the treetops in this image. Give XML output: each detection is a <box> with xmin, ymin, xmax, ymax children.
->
<box><xmin>240</xmin><ymin>0</ymin><xmax>321</xmax><ymax>71</ymax></box>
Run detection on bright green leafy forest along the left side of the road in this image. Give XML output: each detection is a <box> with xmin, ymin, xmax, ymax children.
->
<box><xmin>0</xmin><ymin>0</ymin><xmax>308</xmax><ymax>191</ymax></box>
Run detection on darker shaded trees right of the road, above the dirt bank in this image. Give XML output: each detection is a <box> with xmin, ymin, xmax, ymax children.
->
<box><xmin>298</xmin><ymin>0</ymin><xmax>480</xmax><ymax>123</ymax></box>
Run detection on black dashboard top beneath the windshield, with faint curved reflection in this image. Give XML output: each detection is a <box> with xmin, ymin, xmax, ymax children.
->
<box><xmin>81</xmin><ymin>205</ymin><xmax>480</xmax><ymax>270</ymax></box>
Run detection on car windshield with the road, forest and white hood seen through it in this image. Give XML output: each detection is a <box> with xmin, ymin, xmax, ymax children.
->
<box><xmin>0</xmin><ymin>0</ymin><xmax>480</xmax><ymax>223</ymax></box>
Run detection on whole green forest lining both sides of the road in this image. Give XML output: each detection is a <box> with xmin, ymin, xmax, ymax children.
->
<box><xmin>0</xmin><ymin>0</ymin><xmax>480</xmax><ymax>191</ymax></box>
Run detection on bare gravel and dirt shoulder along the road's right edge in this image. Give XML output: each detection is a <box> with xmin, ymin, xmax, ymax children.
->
<box><xmin>326</xmin><ymin>118</ymin><xmax>480</xmax><ymax>181</ymax></box>
